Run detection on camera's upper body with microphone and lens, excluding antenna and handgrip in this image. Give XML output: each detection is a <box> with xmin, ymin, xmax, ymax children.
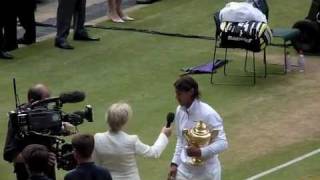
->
<box><xmin>9</xmin><ymin>91</ymin><xmax>93</xmax><ymax>137</ymax></box>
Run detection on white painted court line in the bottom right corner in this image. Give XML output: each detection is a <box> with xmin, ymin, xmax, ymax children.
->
<box><xmin>246</xmin><ymin>148</ymin><xmax>320</xmax><ymax>180</ymax></box>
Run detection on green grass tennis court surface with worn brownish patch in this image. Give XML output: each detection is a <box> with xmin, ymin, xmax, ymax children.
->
<box><xmin>0</xmin><ymin>0</ymin><xmax>320</xmax><ymax>180</ymax></box>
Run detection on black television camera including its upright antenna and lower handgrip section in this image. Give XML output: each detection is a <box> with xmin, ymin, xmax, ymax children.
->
<box><xmin>8</xmin><ymin>80</ymin><xmax>93</xmax><ymax>170</ymax></box>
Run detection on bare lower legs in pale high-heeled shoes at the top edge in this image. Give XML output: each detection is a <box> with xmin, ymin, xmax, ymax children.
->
<box><xmin>108</xmin><ymin>0</ymin><xmax>134</xmax><ymax>23</ymax></box>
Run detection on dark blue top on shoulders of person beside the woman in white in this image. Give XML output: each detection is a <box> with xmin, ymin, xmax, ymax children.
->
<box><xmin>64</xmin><ymin>162</ymin><xmax>112</xmax><ymax>180</ymax></box>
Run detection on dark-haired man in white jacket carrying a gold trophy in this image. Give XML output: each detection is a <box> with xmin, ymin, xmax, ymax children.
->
<box><xmin>168</xmin><ymin>76</ymin><xmax>228</xmax><ymax>180</ymax></box>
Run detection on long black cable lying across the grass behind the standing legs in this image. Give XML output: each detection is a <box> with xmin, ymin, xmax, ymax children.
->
<box><xmin>36</xmin><ymin>22</ymin><xmax>215</xmax><ymax>41</ymax></box>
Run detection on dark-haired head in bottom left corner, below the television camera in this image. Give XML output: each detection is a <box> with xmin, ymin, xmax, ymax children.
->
<box><xmin>21</xmin><ymin>144</ymin><xmax>52</xmax><ymax>180</ymax></box>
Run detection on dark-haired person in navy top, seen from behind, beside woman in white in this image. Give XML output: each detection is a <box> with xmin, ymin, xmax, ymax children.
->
<box><xmin>64</xmin><ymin>134</ymin><xmax>112</xmax><ymax>180</ymax></box>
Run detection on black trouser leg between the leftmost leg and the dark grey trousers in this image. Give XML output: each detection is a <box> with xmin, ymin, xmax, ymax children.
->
<box><xmin>17</xmin><ymin>0</ymin><xmax>36</xmax><ymax>42</ymax></box>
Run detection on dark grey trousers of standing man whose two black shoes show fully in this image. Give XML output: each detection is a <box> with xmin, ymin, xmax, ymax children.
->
<box><xmin>56</xmin><ymin>0</ymin><xmax>87</xmax><ymax>42</ymax></box>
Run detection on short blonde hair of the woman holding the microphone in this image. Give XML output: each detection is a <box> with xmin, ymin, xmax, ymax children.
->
<box><xmin>105</xmin><ymin>102</ymin><xmax>132</xmax><ymax>132</ymax></box>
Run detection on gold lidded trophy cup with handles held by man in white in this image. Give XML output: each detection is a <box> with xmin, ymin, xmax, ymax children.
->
<box><xmin>182</xmin><ymin>121</ymin><xmax>219</xmax><ymax>166</ymax></box>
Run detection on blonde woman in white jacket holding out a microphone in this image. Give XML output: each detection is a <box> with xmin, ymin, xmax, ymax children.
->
<box><xmin>94</xmin><ymin>103</ymin><xmax>171</xmax><ymax>180</ymax></box>
